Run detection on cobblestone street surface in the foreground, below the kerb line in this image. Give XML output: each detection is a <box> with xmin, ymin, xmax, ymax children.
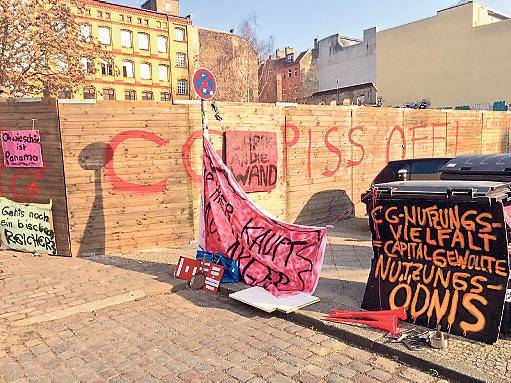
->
<box><xmin>0</xmin><ymin>290</ymin><xmax>448</xmax><ymax>383</ymax></box>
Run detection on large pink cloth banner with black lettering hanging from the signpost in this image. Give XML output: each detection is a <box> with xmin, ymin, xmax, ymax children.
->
<box><xmin>200</xmin><ymin>134</ymin><xmax>327</xmax><ymax>297</ymax></box>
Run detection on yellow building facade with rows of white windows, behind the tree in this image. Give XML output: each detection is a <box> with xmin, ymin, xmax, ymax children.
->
<box><xmin>68</xmin><ymin>0</ymin><xmax>198</xmax><ymax>101</ymax></box>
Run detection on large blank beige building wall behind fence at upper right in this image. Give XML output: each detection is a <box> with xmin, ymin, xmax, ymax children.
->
<box><xmin>376</xmin><ymin>3</ymin><xmax>511</xmax><ymax>107</ymax></box>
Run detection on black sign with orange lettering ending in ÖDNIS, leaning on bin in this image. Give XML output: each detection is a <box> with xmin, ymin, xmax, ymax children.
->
<box><xmin>362</xmin><ymin>200</ymin><xmax>509</xmax><ymax>344</ymax></box>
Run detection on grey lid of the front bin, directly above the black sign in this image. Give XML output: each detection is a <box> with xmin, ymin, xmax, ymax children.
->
<box><xmin>374</xmin><ymin>180</ymin><xmax>511</xmax><ymax>201</ymax></box>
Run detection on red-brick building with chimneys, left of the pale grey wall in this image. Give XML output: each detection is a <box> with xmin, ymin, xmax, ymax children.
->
<box><xmin>259</xmin><ymin>47</ymin><xmax>318</xmax><ymax>102</ymax></box>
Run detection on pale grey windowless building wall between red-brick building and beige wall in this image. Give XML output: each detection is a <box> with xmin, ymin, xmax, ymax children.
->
<box><xmin>319</xmin><ymin>28</ymin><xmax>376</xmax><ymax>92</ymax></box>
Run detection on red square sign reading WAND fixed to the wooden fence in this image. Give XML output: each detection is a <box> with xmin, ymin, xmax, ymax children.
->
<box><xmin>225</xmin><ymin>131</ymin><xmax>277</xmax><ymax>193</ymax></box>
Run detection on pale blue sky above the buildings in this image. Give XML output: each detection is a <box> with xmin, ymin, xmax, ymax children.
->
<box><xmin>113</xmin><ymin>0</ymin><xmax>511</xmax><ymax>51</ymax></box>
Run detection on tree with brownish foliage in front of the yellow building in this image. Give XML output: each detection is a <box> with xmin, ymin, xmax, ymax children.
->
<box><xmin>0</xmin><ymin>0</ymin><xmax>109</xmax><ymax>97</ymax></box>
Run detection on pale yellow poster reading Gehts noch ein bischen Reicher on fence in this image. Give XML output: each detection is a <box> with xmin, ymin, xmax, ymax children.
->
<box><xmin>0</xmin><ymin>197</ymin><xmax>57</xmax><ymax>255</ymax></box>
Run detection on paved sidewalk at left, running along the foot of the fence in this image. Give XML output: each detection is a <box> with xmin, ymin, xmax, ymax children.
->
<box><xmin>0</xmin><ymin>246</ymin><xmax>193</xmax><ymax>332</ymax></box>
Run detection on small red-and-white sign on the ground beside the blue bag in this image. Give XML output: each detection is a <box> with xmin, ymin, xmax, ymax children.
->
<box><xmin>174</xmin><ymin>257</ymin><xmax>224</xmax><ymax>293</ymax></box>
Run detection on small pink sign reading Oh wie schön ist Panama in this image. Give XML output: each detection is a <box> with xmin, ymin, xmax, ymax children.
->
<box><xmin>2</xmin><ymin>130</ymin><xmax>43</xmax><ymax>168</ymax></box>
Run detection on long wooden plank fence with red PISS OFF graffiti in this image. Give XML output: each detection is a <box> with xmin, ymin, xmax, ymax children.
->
<box><xmin>0</xmin><ymin>101</ymin><xmax>511</xmax><ymax>255</ymax></box>
